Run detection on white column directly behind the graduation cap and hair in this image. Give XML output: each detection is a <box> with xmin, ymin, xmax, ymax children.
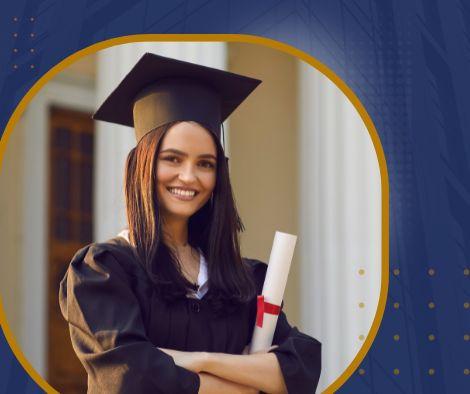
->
<box><xmin>94</xmin><ymin>42</ymin><xmax>226</xmax><ymax>241</ymax></box>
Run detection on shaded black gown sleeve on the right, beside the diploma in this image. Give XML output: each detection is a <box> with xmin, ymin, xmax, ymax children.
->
<box><xmin>248</xmin><ymin>260</ymin><xmax>321</xmax><ymax>394</ymax></box>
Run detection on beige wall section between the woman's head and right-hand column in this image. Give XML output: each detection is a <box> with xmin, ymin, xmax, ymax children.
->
<box><xmin>228</xmin><ymin>43</ymin><xmax>300</xmax><ymax>324</ymax></box>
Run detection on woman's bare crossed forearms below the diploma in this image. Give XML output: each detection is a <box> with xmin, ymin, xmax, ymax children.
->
<box><xmin>159</xmin><ymin>348</ymin><xmax>287</xmax><ymax>394</ymax></box>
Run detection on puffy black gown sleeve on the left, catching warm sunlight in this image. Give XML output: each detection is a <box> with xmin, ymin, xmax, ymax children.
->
<box><xmin>59</xmin><ymin>244</ymin><xmax>200</xmax><ymax>394</ymax></box>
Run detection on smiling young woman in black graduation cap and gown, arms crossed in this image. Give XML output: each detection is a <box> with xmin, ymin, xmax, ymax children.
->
<box><xmin>60</xmin><ymin>54</ymin><xmax>321</xmax><ymax>393</ymax></box>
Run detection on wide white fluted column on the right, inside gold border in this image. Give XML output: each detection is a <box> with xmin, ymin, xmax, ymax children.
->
<box><xmin>299</xmin><ymin>62</ymin><xmax>381</xmax><ymax>392</ymax></box>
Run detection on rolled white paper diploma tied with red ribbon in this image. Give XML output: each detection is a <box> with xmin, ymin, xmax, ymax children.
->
<box><xmin>249</xmin><ymin>231</ymin><xmax>297</xmax><ymax>353</ymax></box>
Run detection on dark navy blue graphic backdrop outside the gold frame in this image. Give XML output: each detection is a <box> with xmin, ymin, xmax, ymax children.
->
<box><xmin>0</xmin><ymin>0</ymin><xmax>470</xmax><ymax>394</ymax></box>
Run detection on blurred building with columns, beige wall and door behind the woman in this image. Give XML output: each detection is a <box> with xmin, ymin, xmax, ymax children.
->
<box><xmin>0</xmin><ymin>42</ymin><xmax>382</xmax><ymax>393</ymax></box>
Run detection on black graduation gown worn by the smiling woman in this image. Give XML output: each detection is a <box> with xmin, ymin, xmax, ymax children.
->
<box><xmin>59</xmin><ymin>237</ymin><xmax>321</xmax><ymax>394</ymax></box>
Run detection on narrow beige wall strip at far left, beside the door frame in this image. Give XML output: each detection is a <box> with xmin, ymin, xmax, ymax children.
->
<box><xmin>0</xmin><ymin>118</ymin><xmax>24</xmax><ymax>340</ymax></box>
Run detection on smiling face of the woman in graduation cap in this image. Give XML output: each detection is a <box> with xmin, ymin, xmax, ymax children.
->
<box><xmin>157</xmin><ymin>122</ymin><xmax>217</xmax><ymax>220</ymax></box>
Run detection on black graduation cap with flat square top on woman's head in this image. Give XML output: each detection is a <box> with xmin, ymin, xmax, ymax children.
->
<box><xmin>93</xmin><ymin>53</ymin><xmax>261</xmax><ymax>141</ymax></box>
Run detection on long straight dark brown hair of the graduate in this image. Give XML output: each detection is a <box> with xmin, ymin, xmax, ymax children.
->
<box><xmin>125</xmin><ymin>122</ymin><xmax>256</xmax><ymax>314</ymax></box>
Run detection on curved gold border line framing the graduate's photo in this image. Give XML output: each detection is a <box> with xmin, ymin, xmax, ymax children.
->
<box><xmin>0</xmin><ymin>34</ymin><xmax>389</xmax><ymax>394</ymax></box>
